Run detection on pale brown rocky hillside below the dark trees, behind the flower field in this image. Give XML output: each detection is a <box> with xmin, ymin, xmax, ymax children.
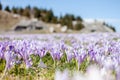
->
<box><xmin>0</xmin><ymin>11</ymin><xmax>114</xmax><ymax>33</ymax></box>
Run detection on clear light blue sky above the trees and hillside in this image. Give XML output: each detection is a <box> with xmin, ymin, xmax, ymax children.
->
<box><xmin>1</xmin><ymin>0</ymin><xmax>120</xmax><ymax>32</ymax></box>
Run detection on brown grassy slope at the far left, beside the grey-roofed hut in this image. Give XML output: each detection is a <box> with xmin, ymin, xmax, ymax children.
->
<box><xmin>0</xmin><ymin>11</ymin><xmax>22</xmax><ymax>31</ymax></box>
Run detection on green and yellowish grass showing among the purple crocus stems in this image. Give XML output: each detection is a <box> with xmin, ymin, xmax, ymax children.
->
<box><xmin>0</xmin><ymin>53</ymin><xmax>92</xmax><ymax>80</ymax></box>
